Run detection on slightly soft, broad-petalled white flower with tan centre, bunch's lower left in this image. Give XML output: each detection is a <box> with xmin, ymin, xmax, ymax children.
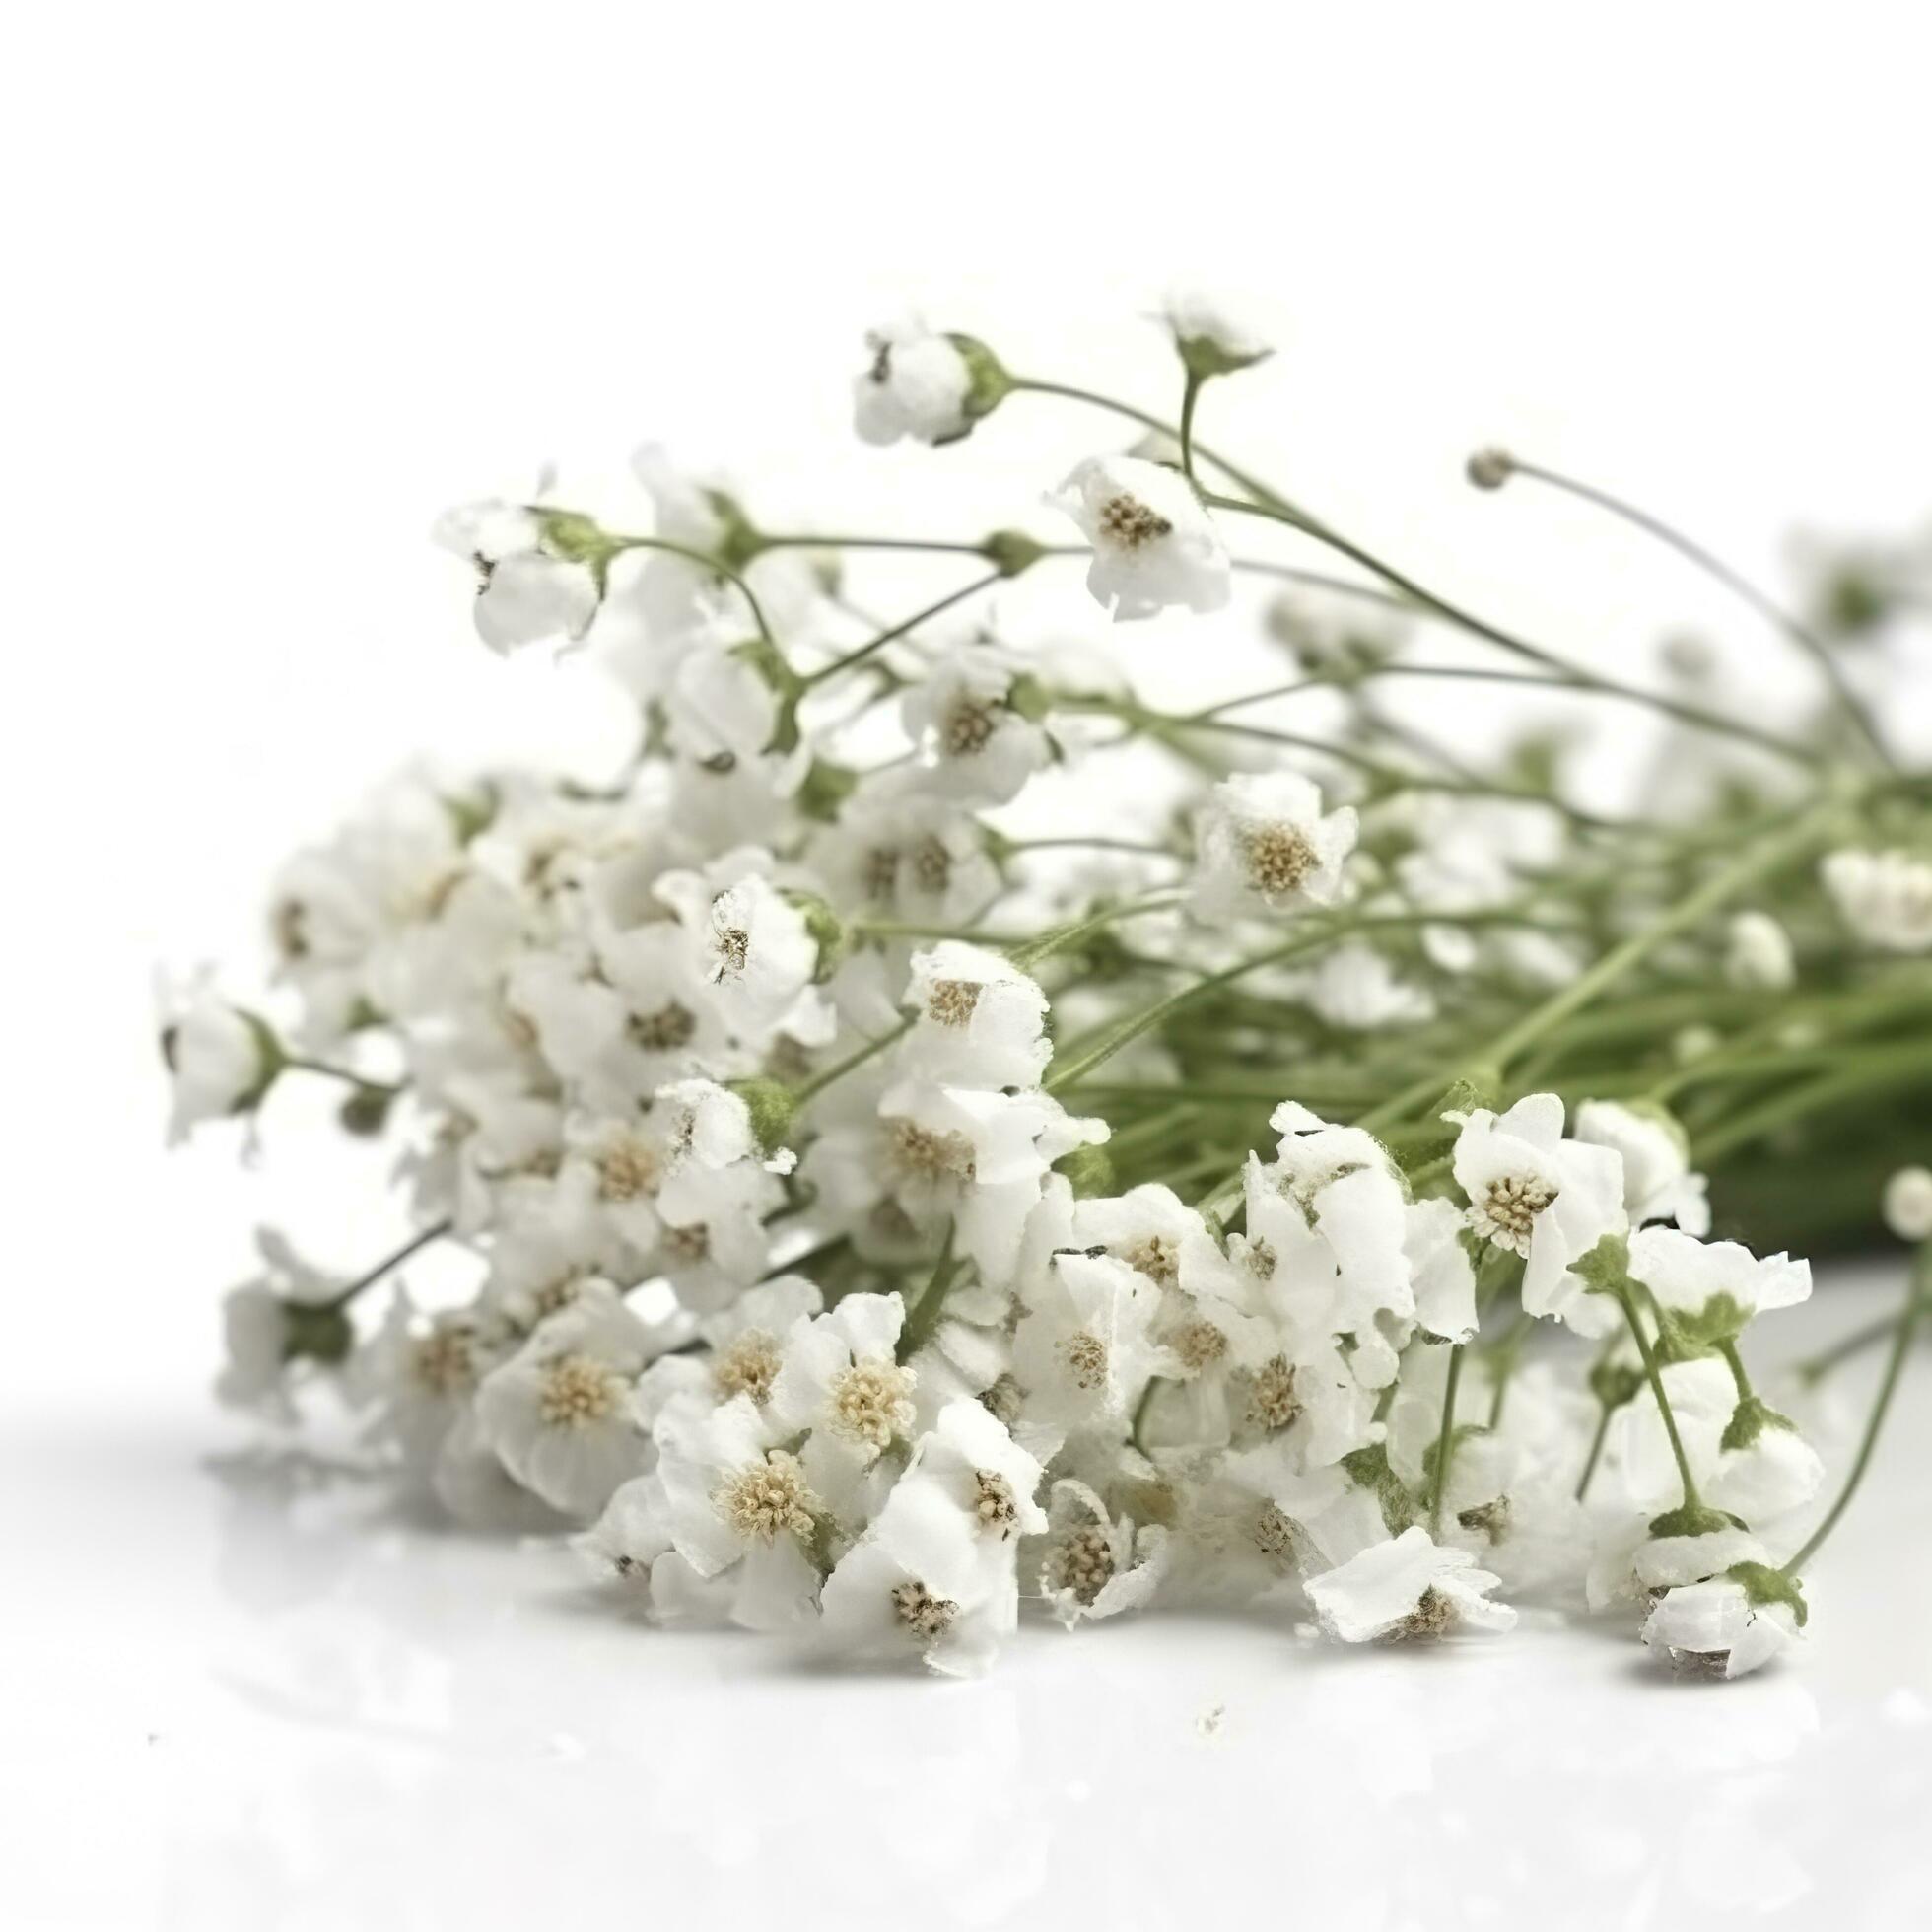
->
<box><xmin>477</xmin><ymin>1280</ymin><xmax>662</xmax><ymax>1521</ymax></box>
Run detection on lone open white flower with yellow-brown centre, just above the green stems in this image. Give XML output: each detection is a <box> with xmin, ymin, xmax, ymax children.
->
<box><xmin>1192</xmin><ymin>771</ymin><xmax>1356</xmax><ymax>920</ymax></box>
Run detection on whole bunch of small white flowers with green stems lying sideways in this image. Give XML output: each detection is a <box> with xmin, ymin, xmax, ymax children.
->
<box><xmin>161</xmin><ymin>294</ymin><xmax>1932</xmax><ymax>1677</ymax></box>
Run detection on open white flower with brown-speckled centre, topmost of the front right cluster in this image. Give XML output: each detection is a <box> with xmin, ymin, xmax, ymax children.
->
<box><xmin>1445</xmin><ymin>1093</ymin><xmax>1628</xmax><ymax>1337</ymax></box>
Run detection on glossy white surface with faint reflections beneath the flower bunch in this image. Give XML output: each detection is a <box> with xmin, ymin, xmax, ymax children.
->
<box><xmin>11</xmin><ymin>1296</ymin><xmax>1932</xmax><ymax>1932</ymax></box>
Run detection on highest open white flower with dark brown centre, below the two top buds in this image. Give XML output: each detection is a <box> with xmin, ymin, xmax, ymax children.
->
<box><xmin>1047</xmin><ymin>456</ymin><xmax>1231</xmax><ymax>620</ymax></box>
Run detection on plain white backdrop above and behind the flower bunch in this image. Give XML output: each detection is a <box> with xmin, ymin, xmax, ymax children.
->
<box><xmin>0</xmin><ymin>0</ymin><xmax>1932</xmax><ymax>1924</ymax></box>
